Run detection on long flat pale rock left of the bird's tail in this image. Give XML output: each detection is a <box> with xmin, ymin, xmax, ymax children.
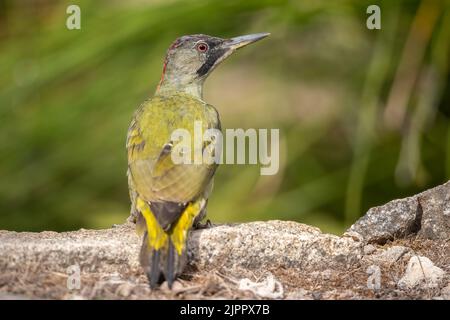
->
<box><xmin>0</xmin><ymin>224</ymin><xmax>140</xmax><ymax>275</ymax></box>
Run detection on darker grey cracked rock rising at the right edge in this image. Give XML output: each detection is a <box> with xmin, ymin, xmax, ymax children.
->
<box><xmin>344</xmin><ymin>181</ymin><xmax>450</xmax><ymax>244</ymax></box>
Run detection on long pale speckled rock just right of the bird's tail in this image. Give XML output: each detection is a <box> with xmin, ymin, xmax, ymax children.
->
<box><xmin>190</xmin><ymin>221</ymin><xmax>361</xmax><ymax>273</ymax></box>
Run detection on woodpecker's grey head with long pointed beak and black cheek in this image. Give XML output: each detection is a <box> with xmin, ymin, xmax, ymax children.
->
<box><xmin>158</xmin><ymin>33</ymin><xmax>269</xmax><ymax>98</ymax></box>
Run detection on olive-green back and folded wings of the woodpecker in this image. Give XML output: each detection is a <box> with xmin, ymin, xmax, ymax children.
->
<box><xmin>127</xmin><ymin>95</ymin><xmax>220</xmax><ymax>203</ymax></box>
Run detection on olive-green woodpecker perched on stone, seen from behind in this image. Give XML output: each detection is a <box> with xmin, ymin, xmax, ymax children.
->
<box><xmin>126</xmin><ymin>33</ymin><xmax>269</xmax><ymax>289</ymax></box>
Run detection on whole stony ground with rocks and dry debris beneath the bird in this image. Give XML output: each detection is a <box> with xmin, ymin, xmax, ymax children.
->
<box><xmin>0</xmin><ymin>183</ymin><xmax>450</xmax><ymax>299</ymax></box>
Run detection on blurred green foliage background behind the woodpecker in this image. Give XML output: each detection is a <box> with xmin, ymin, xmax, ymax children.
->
<box><xmin>0</xmin><ymin>0</ymin><xmax>450</xmax><ymax>233</ymax></box>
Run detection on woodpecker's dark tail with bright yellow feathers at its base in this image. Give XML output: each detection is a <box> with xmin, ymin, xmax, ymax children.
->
<box><xmin>137</xmin><ymin>199</ymin><xmax>202</xmax><ymax>288</ymax></box>
